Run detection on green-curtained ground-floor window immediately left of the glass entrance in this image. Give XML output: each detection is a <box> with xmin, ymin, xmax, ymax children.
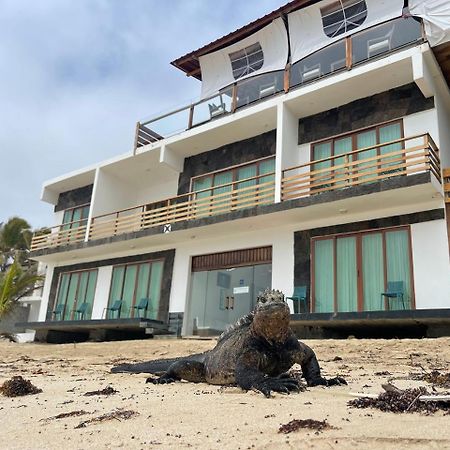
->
<box><xmin>109</xmin><ymin>260</ymin><xmax>164</xmax><ymax>319</ymax></box>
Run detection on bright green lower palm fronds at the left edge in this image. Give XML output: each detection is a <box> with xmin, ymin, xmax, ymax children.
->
<box><xmin>0</xmin><ymin>261</ymin><xmax>44</xmax><ymax>318</ymax></box>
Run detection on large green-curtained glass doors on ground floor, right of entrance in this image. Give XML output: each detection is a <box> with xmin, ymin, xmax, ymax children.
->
<box><xmin>311</xmin><ymin>227</ymin><xmax>414</xmax><ymax>312</ymax></box>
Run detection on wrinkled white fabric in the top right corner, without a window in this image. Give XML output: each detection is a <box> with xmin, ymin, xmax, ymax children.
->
<box><xmin>409</xmin><ymin>0</ymin><xmax>450</xmax><ymax>47</ymax></box>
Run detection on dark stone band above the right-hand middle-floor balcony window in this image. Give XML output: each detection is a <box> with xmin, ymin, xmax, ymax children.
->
<box><xmin>298</xmin><ymin>83</ymin><xmax>434</xmax><ymax>144</ymax></box>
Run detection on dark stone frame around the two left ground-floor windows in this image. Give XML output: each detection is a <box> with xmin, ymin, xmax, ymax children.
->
<box><xmin>47</xmin><ymin>246</ymin><xmax>175</xmax><ymax>322</ymax></box>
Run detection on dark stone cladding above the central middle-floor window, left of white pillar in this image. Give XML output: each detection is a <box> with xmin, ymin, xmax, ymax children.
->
<box><xmin>178</xmin><ymin>130</ymin><xmax>276</xmax><ymax>195</ymax></box>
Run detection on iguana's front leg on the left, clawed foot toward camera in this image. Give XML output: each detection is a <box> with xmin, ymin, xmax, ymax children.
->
<box><xmin>235</xmin><ymin>353</ymin><xmax>300</xmax><ymax>397</ymax></box>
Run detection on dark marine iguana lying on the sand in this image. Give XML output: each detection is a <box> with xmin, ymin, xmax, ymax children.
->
<box><xmin>111</xmin><ymin>289</ymin><xmax>347</xmax><ymax>397</ymax></box>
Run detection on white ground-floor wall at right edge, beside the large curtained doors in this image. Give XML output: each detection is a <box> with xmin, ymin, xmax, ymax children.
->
<box><xmin>411</xmin><ymin>220</ymin><xmax>450</xmax><ymax>309</ymax></box>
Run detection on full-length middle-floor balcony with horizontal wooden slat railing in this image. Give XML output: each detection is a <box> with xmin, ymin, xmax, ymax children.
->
<box><xmin>31</xmin><ymin>134</ymin><xmax>442</xmax><ymax>251</ymax></box>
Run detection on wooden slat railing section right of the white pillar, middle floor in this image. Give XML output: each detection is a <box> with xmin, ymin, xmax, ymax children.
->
<box><xmin>281</xmin><ymin>134</ymin><xmax>441</xmax><ymax>200</ymax></box>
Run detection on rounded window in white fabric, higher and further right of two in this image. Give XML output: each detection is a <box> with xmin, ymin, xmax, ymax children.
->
<box><xmin>320</xmin><ymin>0</ymin><xmax>367</xmax><ymax>38</ymax></box>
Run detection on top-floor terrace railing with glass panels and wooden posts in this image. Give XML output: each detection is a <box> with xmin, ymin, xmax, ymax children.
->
<box><xmin>135</xmin><ymin>18</ymin><xmax>423</xmax><ymax>151</ymax></box>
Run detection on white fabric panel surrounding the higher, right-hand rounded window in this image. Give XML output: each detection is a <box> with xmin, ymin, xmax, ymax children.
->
<box><xmin>288</xmin><ymin>0</ymin><xmax>404</xmax><ymax>63</ymax></box>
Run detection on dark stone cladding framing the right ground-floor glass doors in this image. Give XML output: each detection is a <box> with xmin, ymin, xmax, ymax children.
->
<box><xmin>294</xmin><ymin>209</ymin><xmax>444</xmax><ymax>310</ymax></box>
